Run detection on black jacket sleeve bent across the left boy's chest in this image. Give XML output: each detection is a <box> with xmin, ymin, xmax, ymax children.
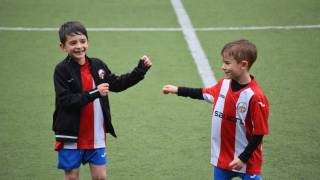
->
<box><xmin>54</xmin><ymin>66</ymin><xmax>100</xmax><ymax>108</ymax></box>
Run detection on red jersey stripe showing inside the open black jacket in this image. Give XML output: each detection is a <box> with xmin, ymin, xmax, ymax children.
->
<box><xmin>77</xmin><ymin>61</ymin><xmax>94</xmax><ymax>149</ymax></box>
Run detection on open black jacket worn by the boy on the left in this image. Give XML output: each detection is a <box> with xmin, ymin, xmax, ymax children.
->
<box><xmin>52</xmin><ymin>56</ymin><xmax>148</xmax><ymax>142</ymax></box>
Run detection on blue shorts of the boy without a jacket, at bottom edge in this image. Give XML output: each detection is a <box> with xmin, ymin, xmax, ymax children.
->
<box><xmin>213</xmin><ymin>167</ymin><xmax>261</xmax><ymax>180</ymax></box>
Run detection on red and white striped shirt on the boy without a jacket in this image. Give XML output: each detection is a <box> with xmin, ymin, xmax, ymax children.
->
<box><xmin>202</xmin><ymin>79</ymin><xmax>269</xmax><ymax>174</ymax></box>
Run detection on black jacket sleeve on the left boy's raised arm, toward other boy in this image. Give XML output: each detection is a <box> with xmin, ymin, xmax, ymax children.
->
<box><xmin>104</xmin><ymin>60</ymin><xmax>149</xmax><ymax>92</ymax></box>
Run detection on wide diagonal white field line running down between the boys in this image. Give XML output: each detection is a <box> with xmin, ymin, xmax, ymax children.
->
<box><xmin>171</xmin><ymin>0</ymin><xmax>217</xmax><ymax>87</ymax></box>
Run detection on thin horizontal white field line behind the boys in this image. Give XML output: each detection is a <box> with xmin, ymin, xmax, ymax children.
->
<box><xmin>0</xmin><ymin>24</ymin><xmax>320</xmax><ymax>32</ymax></box>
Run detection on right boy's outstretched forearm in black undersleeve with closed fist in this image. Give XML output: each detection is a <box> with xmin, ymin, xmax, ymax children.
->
<box><xmin>162</xmin><ymin>85</ymin><xmax>203</xmax><ymax>100</ymax></box>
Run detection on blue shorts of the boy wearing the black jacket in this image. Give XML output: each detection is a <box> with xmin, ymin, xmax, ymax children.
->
<box><xmin>57</xmin><ymin>148</ymin><xmax>108</xmax><ymax>170</ymax></box>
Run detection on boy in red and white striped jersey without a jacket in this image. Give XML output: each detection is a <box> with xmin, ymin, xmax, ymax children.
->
<box><xmin>162</xmin><ymin>39</ymin><xmax>269</xmax><ymax>180</ymax></box>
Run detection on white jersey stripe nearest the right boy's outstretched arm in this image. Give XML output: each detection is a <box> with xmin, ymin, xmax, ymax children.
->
<box><xmin>210</xmin><ymin>79</ymin><xmax>230</xmax><ymax>166</ymax></box>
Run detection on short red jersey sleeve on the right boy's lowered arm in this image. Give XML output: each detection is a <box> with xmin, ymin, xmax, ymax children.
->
<box><xmin>250</xmin><ymin>96</ymin><xmax>269</xmax><ymax>135</ymax></box>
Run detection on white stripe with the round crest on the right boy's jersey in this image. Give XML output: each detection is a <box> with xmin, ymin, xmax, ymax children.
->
<box><xmin>234</xmin><ymin>88</ymin><xmax>254</xmax><ymax>173</ymax></box>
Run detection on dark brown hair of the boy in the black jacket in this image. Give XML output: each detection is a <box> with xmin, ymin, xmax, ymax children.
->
<box><xmin>59</xmin><ymin>21</ymin><xmax>88</xmax><ymax>44</ymax></box>
